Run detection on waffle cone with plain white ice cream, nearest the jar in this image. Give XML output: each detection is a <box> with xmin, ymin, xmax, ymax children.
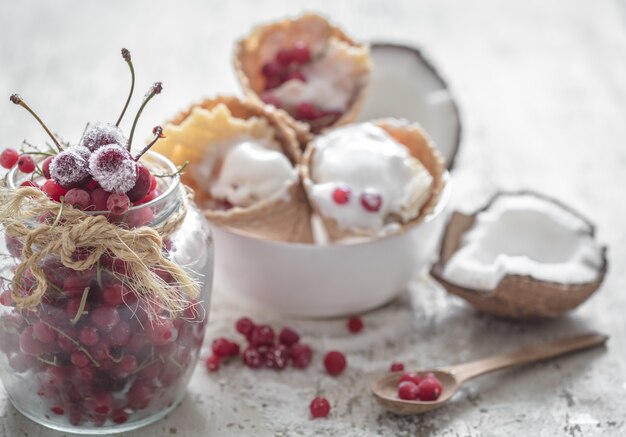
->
<box><xmin>154</xmin><ymin>96</ymin><xmax>312</xmax><ymax>243</ymax></box>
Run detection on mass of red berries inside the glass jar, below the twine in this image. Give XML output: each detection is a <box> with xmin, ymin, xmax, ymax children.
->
<box><xmin>0</xmin><ymin>252</ymin><xmax>206</xmax><ymax>426</ymax></box>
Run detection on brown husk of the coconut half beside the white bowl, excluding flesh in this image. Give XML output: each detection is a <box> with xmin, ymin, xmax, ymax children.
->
<box><xmin>430</xmin><ymin>192</ymin><xmax>608</xmax><ymax>319</ymax></box>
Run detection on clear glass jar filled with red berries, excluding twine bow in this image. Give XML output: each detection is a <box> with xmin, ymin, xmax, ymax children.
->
<box><xmin>0</xmin><ymin>153</ymin><xmax>213</xmax><ymax>434</ymax></box>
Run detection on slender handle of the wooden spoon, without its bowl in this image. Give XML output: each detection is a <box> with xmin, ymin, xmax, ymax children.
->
<box><xmin>446</xmin><ymin>333</ymin><xmax>608</xmax><ymax>383</ymax></box>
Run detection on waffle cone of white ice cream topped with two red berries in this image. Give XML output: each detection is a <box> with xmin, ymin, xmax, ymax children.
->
<box><xmin>301</xmin><ymin>119</ymin><xmax>444</xmax><ymax>242</ymax></box>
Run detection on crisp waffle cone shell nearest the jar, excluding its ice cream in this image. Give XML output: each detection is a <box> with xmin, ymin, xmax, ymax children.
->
<box><xmin>153</xmin><ymin>96</ymin><xmax>313</xmax><ymax>243</ymax></box>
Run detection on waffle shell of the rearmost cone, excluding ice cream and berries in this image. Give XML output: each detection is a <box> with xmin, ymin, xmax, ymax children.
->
<box><xmin>233</xmin><ymin>13</ymin><xmax>371</xmax><ymax>148</ymax></box>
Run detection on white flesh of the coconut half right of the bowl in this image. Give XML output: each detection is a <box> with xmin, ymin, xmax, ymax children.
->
<box><xmin>443</xmin><ymin>194</ymin><xmax>603</xmax><ymax>292</ymax></box>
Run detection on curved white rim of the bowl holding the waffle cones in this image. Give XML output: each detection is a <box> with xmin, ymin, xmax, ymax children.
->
<box><xmin>209</xmin><ymin>170</ymin><xmax>452</xmax><ymax>252</ymax></box>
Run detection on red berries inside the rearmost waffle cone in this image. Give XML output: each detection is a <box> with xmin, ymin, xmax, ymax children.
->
<box><xmin>261</xmin><ymin>41</ymin><xmax>342</xmax><ymax>132</ymax></box>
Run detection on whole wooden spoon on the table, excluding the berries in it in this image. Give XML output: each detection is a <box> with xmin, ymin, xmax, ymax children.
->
<box><xmin>372</xmin><ymin>333</ymin><xmax>608</xmax><ymax>415</ymax></box>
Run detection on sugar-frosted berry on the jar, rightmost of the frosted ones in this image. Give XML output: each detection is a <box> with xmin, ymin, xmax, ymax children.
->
<box><xmin>89</xmin><ymin>144</ymin><xmax>137</xmax><ymax>193</ymax></box>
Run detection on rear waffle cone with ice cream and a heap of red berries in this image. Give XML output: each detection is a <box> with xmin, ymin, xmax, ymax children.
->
<box><xmin>234</xmin><ymin>14</ymin><xmax>372</xmax><ymax>144</ymax></box>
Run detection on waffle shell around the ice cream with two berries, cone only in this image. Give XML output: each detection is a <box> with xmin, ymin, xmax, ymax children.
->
<box><xmin>301</xmin><ymin>119</ymin><xmax>445</xmax><ymax>242</ymax></box>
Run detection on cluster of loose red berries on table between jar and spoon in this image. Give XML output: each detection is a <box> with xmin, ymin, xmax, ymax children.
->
<box><xmin>206</xmin><ymin>317</ymin><xmax>313</xmax><ymax>372</ymax></box>
